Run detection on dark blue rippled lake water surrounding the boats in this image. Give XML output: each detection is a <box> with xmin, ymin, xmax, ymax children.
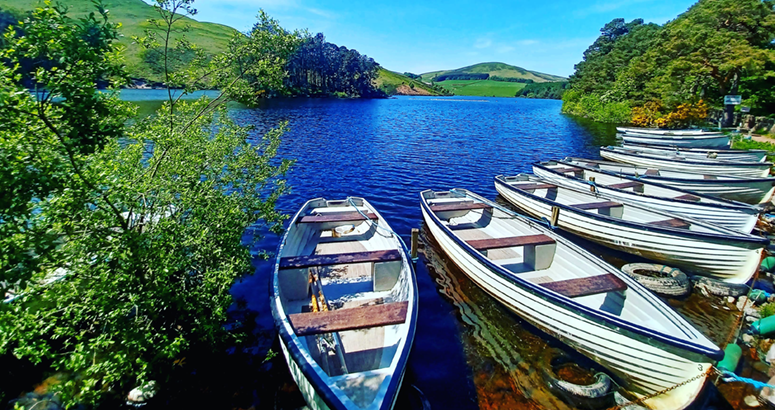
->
<box><xmin>159</xmin><ymin>97</ymin><xmax>732</xmax><ymax>409</ymax></box>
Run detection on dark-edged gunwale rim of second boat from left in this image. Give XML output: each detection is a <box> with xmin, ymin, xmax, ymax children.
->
<box><xmin>420</xmin><ymin>188</ymin><xmax>724</xmax><ymax>361</ymax></box>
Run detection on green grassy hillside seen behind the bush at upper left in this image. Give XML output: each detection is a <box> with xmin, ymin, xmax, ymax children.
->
<box><xmin>0</xmin><ymin>0</ymin><xmax>239</xmax><ymax>81</ymax></box>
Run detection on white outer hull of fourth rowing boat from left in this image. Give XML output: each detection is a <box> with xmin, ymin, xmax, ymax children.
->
<box><xmin>533</xmin><ymin>164</ymin><xmax>759</xmax><ymax>234</ymax></box>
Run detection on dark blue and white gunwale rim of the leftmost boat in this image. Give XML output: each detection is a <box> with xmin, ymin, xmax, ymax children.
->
<box><xmin>270</xmin><ymin>197</ymin><xmax>419</xmax><ymax>410</ymax></box>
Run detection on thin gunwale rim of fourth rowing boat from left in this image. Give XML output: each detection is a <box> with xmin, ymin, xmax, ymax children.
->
<box><xmin>533</xmin><ymin>161</ymin><xmax>760</xmax><ymax>214</ymax></box>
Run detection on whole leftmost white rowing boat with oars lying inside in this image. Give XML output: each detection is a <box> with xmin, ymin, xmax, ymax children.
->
<box><xmin>271</xmin><ymin>198</ymin><xmax>417</xmax><ymax>410</ymax></box>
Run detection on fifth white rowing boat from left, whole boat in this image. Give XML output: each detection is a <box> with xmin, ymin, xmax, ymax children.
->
<box><xmin>563</xmin><ymin>157</ymin><xmax>775</xmax><ymax>204</ymax></box>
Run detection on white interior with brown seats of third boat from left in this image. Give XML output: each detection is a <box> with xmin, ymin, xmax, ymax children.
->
<box><xmin>499</xmin><ymin>174</ymin><xmax>730</xmax><ymax>234</ymax></box>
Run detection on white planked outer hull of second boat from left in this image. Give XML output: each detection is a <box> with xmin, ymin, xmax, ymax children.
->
<box><xmin>422</xmin><ymin>200</ymin><xmax>712</xmax><ymax>410</ymax></box>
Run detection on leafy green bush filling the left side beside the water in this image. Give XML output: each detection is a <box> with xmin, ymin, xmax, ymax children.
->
<box><xmin>0</xmin><ymin>0</ymin><xmax>295</xmax><ymax>407</ymax></box>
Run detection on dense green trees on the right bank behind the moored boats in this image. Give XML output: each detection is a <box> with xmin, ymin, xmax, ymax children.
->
<box><xmin>563</xmin><ymin>0</ymin><xmax>775</xmax><ymax>126</ymax></box>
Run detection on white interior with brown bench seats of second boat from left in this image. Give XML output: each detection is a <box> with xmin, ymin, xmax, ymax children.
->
<box><xmin>423</xmin><ymin>190</ymin><xmax>695</xmax><ymax>337</ymax></box>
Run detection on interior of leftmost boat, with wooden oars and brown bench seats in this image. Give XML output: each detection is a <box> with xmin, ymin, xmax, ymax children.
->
<box><xmin>278</xmin><ymin>198</ymin><xmax>415</xmax><ymax>407</ymax></box>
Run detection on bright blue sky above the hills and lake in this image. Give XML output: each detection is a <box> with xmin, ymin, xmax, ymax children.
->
<box><xmin>186</xmin><ymin>0</ymin><xmax>696</xmax><ymax>76</ymax></box>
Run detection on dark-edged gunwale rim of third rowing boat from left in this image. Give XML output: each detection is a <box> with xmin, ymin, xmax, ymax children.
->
<box><xmin>495</xmin><ymin>174</ymin><xmax>770</xmax><ymax>245</ymax></box>
